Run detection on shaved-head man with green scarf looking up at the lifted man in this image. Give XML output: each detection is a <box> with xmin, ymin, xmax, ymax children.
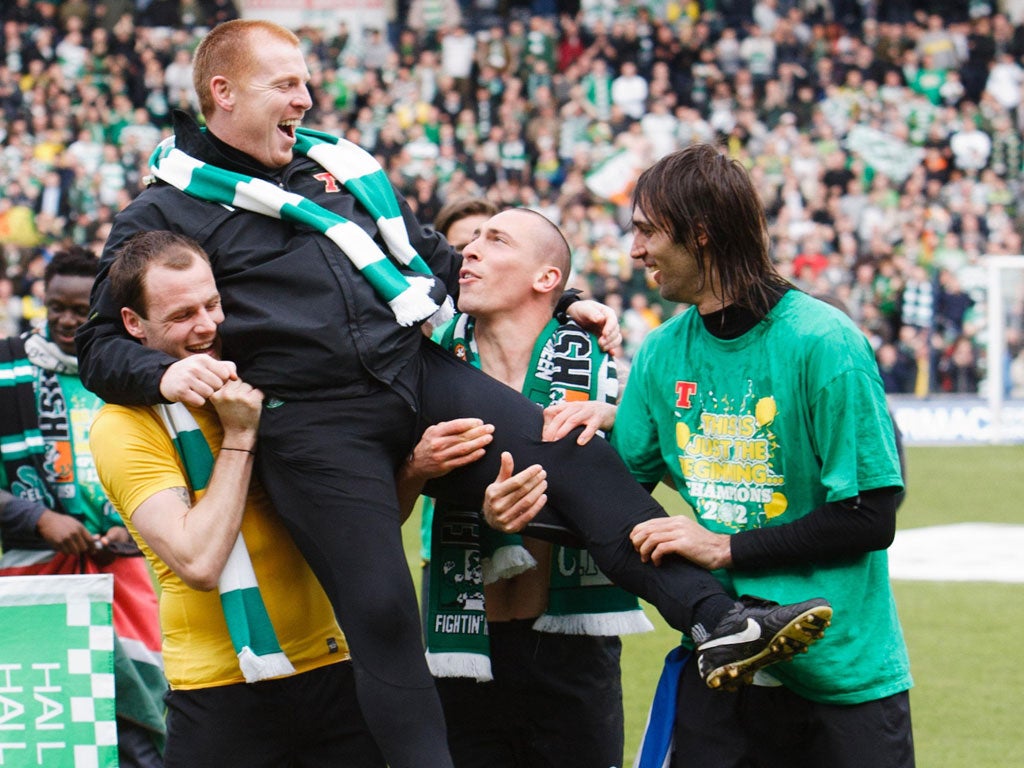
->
<box><xmin>395</xmin><ymin>208</ymin><xmax>650</xmax><ymax>768</ymax></box>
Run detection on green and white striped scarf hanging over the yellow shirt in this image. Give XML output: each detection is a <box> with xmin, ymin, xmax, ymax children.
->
<box><xmin>154</xmin><ymin>402</ymin><xmax>295</xmax><ymax>683</ymax></box>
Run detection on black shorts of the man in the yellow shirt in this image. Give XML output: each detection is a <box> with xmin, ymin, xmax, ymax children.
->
<box><xmin>164</xmin><ymin>663</ymin><xmax>384</xmax><ymax>768</ymax></box>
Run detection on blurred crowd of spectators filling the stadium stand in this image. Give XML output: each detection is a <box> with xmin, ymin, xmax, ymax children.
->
<box><xmin>0</xmin><ymin>0</ymin><xmax>1024</xmax><ymax>394</ymax></box>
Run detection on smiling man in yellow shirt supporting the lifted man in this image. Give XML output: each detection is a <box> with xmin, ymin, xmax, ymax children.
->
<box><xmin>91</xmin><ymin>231</ymin><xmax>384</xmax><ymax>768</ymax></box>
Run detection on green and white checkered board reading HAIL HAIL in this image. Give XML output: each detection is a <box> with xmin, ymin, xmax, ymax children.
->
<box><xmin>0</xmin><ymin>573</ymin><xmax>118</xmax><ymax>768</ymax></box>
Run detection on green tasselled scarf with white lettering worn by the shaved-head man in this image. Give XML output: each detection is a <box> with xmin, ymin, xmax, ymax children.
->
<box><xmin>426</xmin><ymin>314</ymin><xmax>653</xmax><ymax>681</ymax></box>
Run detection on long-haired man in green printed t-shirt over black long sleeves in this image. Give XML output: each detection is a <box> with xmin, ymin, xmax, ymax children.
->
<box><xmin>612</xmin><ymin>145</ymin><xmax>914</xmax><ymax>768</ymax></box>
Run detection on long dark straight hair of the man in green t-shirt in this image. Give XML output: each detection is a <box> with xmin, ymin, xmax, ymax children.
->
<box><xmin>633</xmin><ymin>144</ymin><xmax>793</xmax><ymax>317</ymax></box>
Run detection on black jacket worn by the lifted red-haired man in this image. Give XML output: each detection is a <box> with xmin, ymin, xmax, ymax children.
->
<box><xmin>76</xmin><ymin>113</ymin><xmax>461</xmax><ymax>404</ymax></box>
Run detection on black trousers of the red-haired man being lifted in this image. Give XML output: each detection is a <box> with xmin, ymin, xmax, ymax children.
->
<box><xmin>251</xmin><ymin>339</ymin><xmax>722</xmax><ymax>768</ymax></box>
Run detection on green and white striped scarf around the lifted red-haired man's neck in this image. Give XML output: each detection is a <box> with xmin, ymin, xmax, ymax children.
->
<box><xmin>150</xmin><ymin>128</ymin><xmax>455</xmax><ymax>326</ymax></box>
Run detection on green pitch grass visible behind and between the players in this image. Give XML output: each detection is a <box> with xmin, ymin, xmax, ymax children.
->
<box><xmin>404</xmin><ymin>446</ymin><xmax>1024</xmax><ymax>768</ymax></box>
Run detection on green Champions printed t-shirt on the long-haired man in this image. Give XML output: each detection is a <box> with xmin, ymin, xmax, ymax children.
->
<box><xmin>612</xmin><ymin>291</ymin><xmax>911</xmax><ymax>703</ymax></box>
